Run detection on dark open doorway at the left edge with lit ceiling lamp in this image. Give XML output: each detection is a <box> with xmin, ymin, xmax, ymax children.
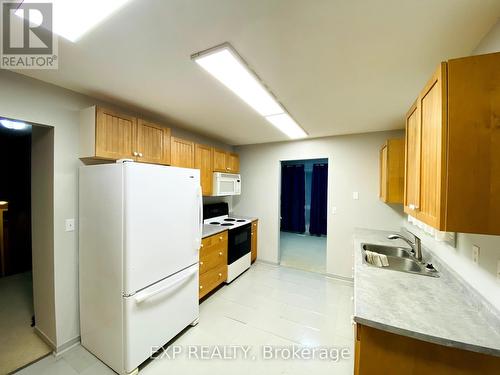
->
<box><xmin>0</xmin><ymin>118</ymin><xmax>52</xmax><ymax>374</ymax></box>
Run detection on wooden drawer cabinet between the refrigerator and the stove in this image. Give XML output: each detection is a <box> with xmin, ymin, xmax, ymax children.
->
<box><xmin>199</xmin><ymin>231</ymin><xmax>227</xmax><ymax>299</ymax></box>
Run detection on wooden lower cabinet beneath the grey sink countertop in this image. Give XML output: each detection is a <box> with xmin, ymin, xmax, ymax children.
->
<box><xmin>354</xmin><ymin>324</ymin><xmax>500</xmax><ymax>375</ymax></box>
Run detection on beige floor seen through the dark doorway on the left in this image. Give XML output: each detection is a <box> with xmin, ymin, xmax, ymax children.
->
<box><xmin>0</xmin><ymin>272</ymin><xmax>51</xmax><ymax>374</ymax></box>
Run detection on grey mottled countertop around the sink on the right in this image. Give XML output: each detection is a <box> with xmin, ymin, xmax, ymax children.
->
<box><xmin>354</xmin><ymin>229</ymin><xmax>500</xmax><ymax>357</ymax></box>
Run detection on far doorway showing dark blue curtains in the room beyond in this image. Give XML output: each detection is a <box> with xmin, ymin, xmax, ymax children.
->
<box><xmin>279</xmin><ymin>159</ymin><xmax>328</xmax><ymax>273</ymax></box>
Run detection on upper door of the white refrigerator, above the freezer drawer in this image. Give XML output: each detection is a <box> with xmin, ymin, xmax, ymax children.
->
<box><xmin>123</xmin><ymin>163</ymin><xmax>202</xmax><ymax>295</ymax></box>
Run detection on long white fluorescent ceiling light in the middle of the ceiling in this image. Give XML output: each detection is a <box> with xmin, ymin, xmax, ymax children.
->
<box><xmin>191</xmin><ymin>43</ymin><xmax>307</xmax><ymax>138</ymax></box>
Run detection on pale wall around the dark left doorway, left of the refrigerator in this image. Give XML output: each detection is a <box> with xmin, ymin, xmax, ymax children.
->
<box><xmin>0</xmin><ymin>70</ymin><xmax>231</xmax><ymax>348</ymax></box>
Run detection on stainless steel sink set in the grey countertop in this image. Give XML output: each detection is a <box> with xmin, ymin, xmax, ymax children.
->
<box><xmin>361</xmin><ymin>244</ymin><xmax>439</xmax><ymax>277</ymax></box>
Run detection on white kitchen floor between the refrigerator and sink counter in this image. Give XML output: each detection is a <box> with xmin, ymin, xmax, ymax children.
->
<box><xmin>18</xmin><ymin>262</ymin><xmax>354</xmax><ymax>375</ymax></box>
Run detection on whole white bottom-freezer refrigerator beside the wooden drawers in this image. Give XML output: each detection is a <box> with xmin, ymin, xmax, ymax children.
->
<box><xmin>79</xmin><ymin>162</ymin><xmax>203</xmax><ymax>374</ymax></box>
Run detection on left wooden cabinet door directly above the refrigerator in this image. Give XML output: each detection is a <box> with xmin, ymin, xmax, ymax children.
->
<box><xmin>95</xmin><ymin>107</ymin><xmax>137</xmax><ymax>160</ymax></box>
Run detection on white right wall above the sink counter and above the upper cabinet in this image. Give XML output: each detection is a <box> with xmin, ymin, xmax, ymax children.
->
<box><xmin>405</xmin><ymin>21</ymin><xmax>500</xmax><ymax>311</ymax></box>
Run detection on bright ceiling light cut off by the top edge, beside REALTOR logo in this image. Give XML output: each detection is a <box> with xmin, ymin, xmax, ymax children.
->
<box><xmin>15</xmin><ymin>0</ymin><xmax>130</xmax><ymax>42</ymax></box>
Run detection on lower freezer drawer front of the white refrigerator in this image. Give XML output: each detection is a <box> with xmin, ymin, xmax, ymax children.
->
<box><xmin>124</xmin><ymin>264</ymin><xmax>199</xmax><ymax>373</ymax></box>
